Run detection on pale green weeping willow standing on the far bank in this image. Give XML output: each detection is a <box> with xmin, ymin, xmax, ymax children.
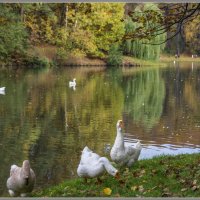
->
<box><xmin>123</xmin><ymin>4</ymin><xmax>166</xmax><ymax>60</ymax></box>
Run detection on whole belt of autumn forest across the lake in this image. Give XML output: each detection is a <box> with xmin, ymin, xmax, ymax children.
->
<box><xmin>0</xmin><ymin>3</ymin><xmax>200</xmax><ymax>66</ymax></box>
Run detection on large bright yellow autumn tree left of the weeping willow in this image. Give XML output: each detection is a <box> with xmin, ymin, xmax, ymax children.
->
<box><xmin>63</xmin><ymin>3</ymin><xmax>124</xmax><ymax>57</ymax></box>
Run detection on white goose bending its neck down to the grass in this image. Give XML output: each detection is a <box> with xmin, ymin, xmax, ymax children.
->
<box><xmin>77</xmin><ymin>146</ymin><xmax>119</xmax><ymax>181</ymax></box>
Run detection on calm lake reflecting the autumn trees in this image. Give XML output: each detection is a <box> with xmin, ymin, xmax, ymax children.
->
<box><xmin>0</xmin><ymin>62</ymin><xmax>200</xmax><ymax>197</ymax></box>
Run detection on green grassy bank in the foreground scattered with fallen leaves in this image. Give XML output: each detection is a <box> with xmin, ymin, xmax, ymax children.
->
<box><xmin>33</xmin><ymin>154</ymin><xmax>200</xmax><ymax>197</ymax></box>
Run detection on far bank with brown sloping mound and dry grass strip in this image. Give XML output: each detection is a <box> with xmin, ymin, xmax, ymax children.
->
<box><xmin>0</xmin><ymin>45</ymin><xmax>200</xmax><ymax>68</ymax></box>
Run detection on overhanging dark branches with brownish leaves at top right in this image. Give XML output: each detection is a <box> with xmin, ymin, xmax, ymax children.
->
<box><xmin>124</xmin><ymin>3</ymin><xmax>200</xmax><ymax>43</ymax></box>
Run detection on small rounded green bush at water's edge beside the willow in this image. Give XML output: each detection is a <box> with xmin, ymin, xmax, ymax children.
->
<box><xmin>107</xmin><ymin>44</ymin><xmax>122</xmax><ymax>66</ymax></box>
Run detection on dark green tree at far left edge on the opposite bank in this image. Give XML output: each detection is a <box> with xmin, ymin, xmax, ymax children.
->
<box><xmin>0</xmin><ymin>4</ymin><xmax>27</xmax><ymax>62</ymax></box>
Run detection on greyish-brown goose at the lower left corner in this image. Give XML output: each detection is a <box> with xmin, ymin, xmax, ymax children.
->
<box><xmin>7</xmin><ymin>160</ymin><xmax>35</xmax><ymax>197</ymax></box>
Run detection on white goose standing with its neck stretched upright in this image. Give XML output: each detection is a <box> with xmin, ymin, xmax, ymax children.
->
<box><xmin>110</xmin><ymin>120</ymin><xmax>142</xmax><ymax>167</ymax></box>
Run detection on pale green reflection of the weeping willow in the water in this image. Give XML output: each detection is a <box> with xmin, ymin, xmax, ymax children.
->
<box><xmin>123</xmin><ymin>69</ymin><xmax>165</xmax><ymax>131</ymax></box>
